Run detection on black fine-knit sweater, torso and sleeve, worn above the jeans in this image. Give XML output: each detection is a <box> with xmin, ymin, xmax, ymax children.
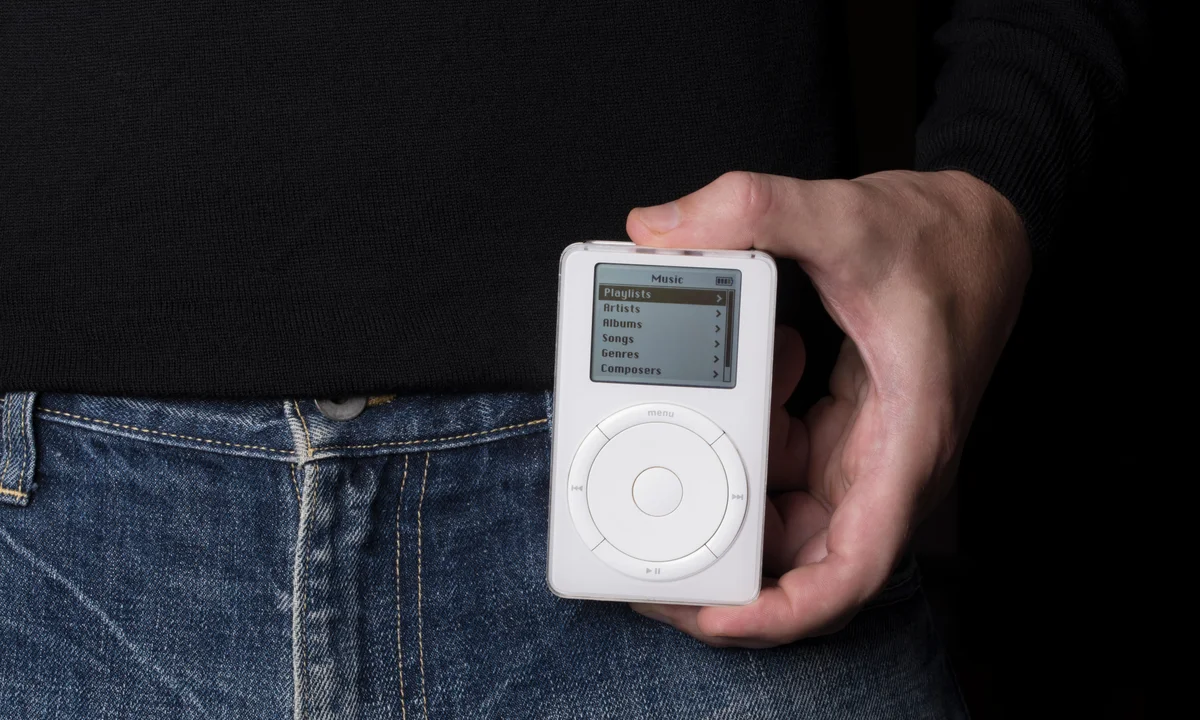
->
<box><xmin>0</xmin><ymin>0</ymin><xmax>1141</xmax><ymax>396</ymax></box>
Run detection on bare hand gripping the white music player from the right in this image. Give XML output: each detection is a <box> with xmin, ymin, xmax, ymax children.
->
<box><xmin>626</xmin><ymin>172</ymin><xmax>1031</xmax><ymax>647</ymax></box>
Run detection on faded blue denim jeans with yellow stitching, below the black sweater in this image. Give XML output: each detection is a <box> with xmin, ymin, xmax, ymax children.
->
<box><xmin>0</xmin><ymin>392</ymin><xmax>965</xmax><ymax>720</ymax></box>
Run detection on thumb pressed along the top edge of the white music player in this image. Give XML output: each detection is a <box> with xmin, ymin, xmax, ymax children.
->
<box><xmin>625</xmin><ymin>172</ymin><xmax>853</xmax><ymax>263</ymax></box>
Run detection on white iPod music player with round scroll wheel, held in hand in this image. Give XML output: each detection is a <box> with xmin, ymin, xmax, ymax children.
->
<box><xmin>546</xmin><ymin>241</ymin><xmax>776</xmax><ymax>605</ymax></box>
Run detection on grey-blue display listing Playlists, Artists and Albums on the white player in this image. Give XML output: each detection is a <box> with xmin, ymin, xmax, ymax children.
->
<box><xmin>592</xmin><ymin>263</ymin><xmax>742</xmax><ymax>388</ymax></box>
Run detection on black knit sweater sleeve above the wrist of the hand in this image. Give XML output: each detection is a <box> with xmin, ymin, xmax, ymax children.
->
<box><xmin>914</xmin><ymin>0</ymin><xmax>1148</xmax><ymax>257</ymax></box>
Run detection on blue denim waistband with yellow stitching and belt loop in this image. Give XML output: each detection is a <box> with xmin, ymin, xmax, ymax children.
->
<box><xmin>0</xmin><ymin>392</ymin><xmax>552</xmax><ymax>505</ymax></box>
